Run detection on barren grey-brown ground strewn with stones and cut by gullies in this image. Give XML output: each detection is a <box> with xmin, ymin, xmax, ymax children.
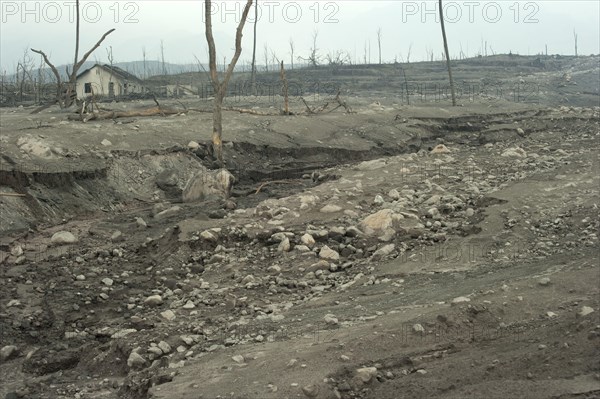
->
<box><xmin>0</xmin><ymin>56</ymin><xmax>600</xmax><ymax>399</ymax></box>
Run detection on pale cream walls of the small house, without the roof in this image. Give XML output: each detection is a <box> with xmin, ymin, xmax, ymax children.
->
<box><xmin>76</xmin><ymin>67</ymin><xmax>143</xmax><ymax>98</ymax></box>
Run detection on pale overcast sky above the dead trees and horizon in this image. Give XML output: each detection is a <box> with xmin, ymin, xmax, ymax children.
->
<box><xmin>0</xmin><ymin>0</ymin><xmax>600</xmax><ymax>73</ymax></box>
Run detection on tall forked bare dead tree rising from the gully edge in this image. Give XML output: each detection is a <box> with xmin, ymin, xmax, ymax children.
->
<box><xmin>204</xmin><ymin>0</ymin><xmax>253</xmax><ymax>166</ymax></box>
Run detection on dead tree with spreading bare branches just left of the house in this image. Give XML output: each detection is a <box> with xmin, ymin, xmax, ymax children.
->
<box><xmin>31</xmin><ymin>0</ymin><xmax>115</xmax><ymax>108</ymax></box>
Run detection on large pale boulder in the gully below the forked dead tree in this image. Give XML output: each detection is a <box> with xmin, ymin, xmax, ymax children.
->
<box><xmin>182</xmin><ymin>168</ymin><xmax>235</xmax><ymax>202</ymax></box>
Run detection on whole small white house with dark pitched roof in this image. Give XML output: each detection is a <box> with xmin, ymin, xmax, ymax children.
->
<box><xmin>77</xmin><ymin>64</ymin><xmax>144</xmax><ymax>98</ymax></box>
